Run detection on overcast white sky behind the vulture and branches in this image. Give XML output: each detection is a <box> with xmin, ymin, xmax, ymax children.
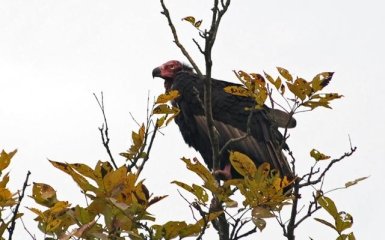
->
<box><xmin>0</xmin><ymin>0</ymin><xmax>385</xmax><ymax>239</ymax></box>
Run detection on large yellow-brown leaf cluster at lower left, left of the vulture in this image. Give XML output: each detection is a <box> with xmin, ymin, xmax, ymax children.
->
<box><xmin>29</xmin><ymin>161</ymin><xmax>165</xmax><ymax>239</ymax></box>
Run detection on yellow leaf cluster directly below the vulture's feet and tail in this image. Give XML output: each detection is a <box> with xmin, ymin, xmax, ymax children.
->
<box><xmin>173</xmin><ymin>152</ymin><xmax>292</xmax><ymax>233</ymax></box>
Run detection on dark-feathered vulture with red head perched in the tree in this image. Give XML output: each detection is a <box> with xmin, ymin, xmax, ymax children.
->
<box><xmin>152</xmin><ymin>60</ymin><xmax>296</xmax><ymax>179</ymax></box>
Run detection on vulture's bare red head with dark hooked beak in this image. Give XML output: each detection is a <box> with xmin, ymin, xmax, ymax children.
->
<box><xmin>152</xmin><ymin>60</ymin><xmax>192</xmax><ymax>92</ymax></box>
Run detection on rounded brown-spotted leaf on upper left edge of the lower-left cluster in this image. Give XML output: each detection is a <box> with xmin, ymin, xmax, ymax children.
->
<box><xmin>32</xmin><ymin>183</ymin><xmax>58</xmax><ymax>207</ymax></box>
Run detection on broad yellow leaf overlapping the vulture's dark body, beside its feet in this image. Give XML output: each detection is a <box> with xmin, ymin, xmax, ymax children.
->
<box><xmin>229</xmin><ymin>152</ymin><xmax>257</xmax><ymax>176</ymax></box>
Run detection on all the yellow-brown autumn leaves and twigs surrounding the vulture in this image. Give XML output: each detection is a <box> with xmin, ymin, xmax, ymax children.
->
<box><xmin>0</xmin><ymin>1</ymin><xmax>366</xmax><ymax>240</ymax></box>
